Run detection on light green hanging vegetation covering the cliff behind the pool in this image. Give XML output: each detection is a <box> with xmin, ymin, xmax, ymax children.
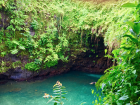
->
<box><xmin>0</xmin><ymin>0</ymin><xmax>136</xmax><ymax>71</ymax></box>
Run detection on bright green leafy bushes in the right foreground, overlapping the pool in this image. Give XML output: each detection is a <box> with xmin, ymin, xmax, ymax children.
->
<box><xmin>96</xmin><ymin>3</ymin><xmax>140</xmax><ymax>105</ymax></box>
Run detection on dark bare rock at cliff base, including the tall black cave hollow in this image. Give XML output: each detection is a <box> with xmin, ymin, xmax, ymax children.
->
<box><xmin>0</xmin><ymin>34</ymin><xmax>113</xmax><ymax>83</ymax></box>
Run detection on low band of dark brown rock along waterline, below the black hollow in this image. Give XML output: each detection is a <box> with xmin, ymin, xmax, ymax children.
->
<box><xmin>0</xmin><ymin>50</ymin><xmax>113</xmax><ymax>81</ymax></box>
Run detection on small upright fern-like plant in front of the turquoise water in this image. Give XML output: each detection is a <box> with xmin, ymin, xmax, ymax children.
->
<box><xmin>43</xmin><ymin>81</ymin><xmax>67</xmax><ymax>105</ymax></box>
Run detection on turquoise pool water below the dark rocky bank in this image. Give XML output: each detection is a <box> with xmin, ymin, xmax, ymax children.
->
<box><xmin>0</xmin><ymin>71</ymin><xmax>101</xmax><ymax>105</ymax></box>
